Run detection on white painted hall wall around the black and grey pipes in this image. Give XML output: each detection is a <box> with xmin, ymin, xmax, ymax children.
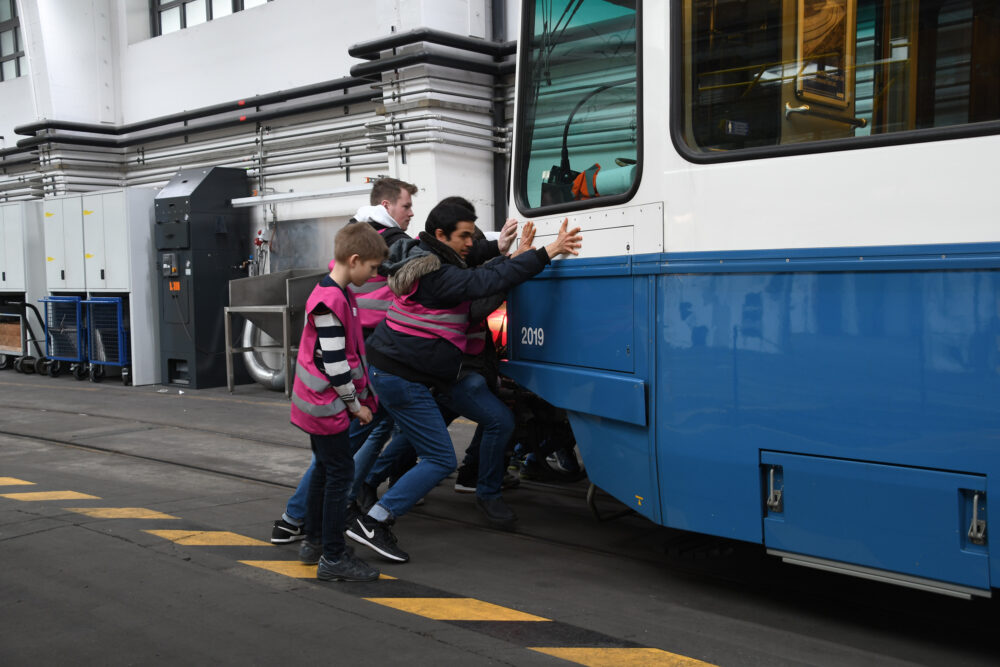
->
<box><xmin>0</xmin><ymin>0</ymin><xmax>518</xmax><ymax>231</ymax></box>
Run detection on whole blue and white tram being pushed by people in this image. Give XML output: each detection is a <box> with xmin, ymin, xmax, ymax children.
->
<box><xmin>505</xmin><ymin>0</ymin><xmax>1000</xmax><ymax>596</ymax></box>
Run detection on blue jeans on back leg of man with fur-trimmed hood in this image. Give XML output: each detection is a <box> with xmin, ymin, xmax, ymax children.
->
<box><xmin>369</xmin><ymin>366</ymin><xmax>457</xmax><ymax>517</ymax></box>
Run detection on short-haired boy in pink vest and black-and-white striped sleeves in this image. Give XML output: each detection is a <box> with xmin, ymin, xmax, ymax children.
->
<box><xmin>291</xmin><ymin>225</ymin><xmax>386</xmax><ymax>581</ymax></box>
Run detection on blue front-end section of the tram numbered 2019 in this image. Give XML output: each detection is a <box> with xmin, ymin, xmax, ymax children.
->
<box><xmin>502</xmin><ymin>257</ymin><xmax>662</xmax><ymax>522</ymax></box>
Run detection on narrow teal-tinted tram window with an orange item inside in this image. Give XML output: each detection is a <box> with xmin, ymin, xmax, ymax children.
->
<box><xmin>515</xmin><ymin>0</ymin><xmax>639</xmax><ymax>209</ymax></box>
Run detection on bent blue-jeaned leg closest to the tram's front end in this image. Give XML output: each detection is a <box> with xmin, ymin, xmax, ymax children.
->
<box><xmin>438</xmin><ymin>373</ymin><xmax>514</xmax><ymax>498</ymax></box>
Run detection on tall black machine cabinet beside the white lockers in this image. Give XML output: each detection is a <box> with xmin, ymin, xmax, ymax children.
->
<box><xmin>155</xmin><ymin>167</ymin><xmax>250</xmax><ymax>389</ymax></box>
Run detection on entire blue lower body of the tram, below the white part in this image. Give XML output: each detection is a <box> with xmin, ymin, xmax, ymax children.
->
<box><xmin>505</xmin><ymin>246</ymin><xmax>1000</xmax><ymax>590</ymax></box>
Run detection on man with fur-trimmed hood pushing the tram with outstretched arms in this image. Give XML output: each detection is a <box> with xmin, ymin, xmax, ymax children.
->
<box><xmin>347</xmin><ymin>203</ymin><xmax>581</xmax><ymax>562</ymax></box>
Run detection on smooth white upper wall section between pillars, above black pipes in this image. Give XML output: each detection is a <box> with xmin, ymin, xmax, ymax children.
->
<box><xmin>122</xmin><ymin>0</ymin><xmax>397</xmax><ymax>123</ymax></box>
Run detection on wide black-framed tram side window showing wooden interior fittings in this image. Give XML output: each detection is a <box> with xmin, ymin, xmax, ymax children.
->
<box><xmin>681</xmin><ymin>0</ymin><xmax>1000</xmax><ymax>153</ymax></box>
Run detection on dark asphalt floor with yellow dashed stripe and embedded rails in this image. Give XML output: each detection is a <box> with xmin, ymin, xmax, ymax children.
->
<box><xmin>0</xmin><ymin>371</ymin><xmax>1000</xmax><ymax>665</ymax></box>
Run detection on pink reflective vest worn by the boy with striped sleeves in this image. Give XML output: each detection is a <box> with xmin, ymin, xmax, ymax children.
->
<box><xmin>291</xmin><ymin>285</ymin><xmax>378</xmax><ymax>435</ymax></box>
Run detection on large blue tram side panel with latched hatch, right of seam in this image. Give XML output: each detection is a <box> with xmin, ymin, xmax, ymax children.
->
<box><xmin>656</xmin><ymin>258</ymin><xmax>1000</xmax><ymax>588</ymax></box>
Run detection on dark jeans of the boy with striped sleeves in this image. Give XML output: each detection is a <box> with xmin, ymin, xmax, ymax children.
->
<box><xmin>306</xmin><ymin>431</ymin><xmax>354</xmax><ymax>561</ymax></box>
